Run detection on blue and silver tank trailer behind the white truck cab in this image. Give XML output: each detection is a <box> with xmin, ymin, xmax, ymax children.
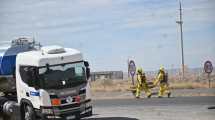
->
<box><xmin>0</xmin><ymin>38</ymin><xmax>35</xmax><ymax>94</ymax></box>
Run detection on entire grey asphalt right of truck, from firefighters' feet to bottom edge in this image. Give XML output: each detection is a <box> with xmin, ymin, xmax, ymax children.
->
<box><xmin>0</xmin><ymin>97</ymin><xmax>215</xmax><ymax>120</ymax></box>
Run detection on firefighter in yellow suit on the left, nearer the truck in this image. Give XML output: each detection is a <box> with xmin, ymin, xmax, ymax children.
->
<box><xmin>136</xmin><ymin>68</ymin><xmax>151</xmax><ymax>98</ymax></box>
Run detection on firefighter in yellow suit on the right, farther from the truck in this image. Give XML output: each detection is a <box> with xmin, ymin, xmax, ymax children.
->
<box><xmin>153</xmin><ymin>66</ymin><xmax>171</xmax><ymax>98</ymax></box>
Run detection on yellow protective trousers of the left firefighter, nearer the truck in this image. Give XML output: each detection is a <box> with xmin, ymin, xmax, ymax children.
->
<box><xmin>136</xmin><ymin>83</ymin><xmax>151</xmax><ymax>97</ymax></box>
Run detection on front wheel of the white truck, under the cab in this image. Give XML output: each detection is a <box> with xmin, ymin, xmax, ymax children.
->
<box><xmin>23</xmin><ymin>104</ymin><xmax>36</xmax><ymax>120</ymax></box>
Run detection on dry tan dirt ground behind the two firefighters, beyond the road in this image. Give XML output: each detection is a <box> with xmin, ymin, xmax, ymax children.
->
<box><xmin>91</xmin><ymin>79</ymin><xmax>215</xmax><ymax>92</ymax></box>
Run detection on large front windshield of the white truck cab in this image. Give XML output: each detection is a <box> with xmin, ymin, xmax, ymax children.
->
<box><xmin>39</xmin><ymin>62</ymin><xmax>87</xmax><ymax>89</ymax></box>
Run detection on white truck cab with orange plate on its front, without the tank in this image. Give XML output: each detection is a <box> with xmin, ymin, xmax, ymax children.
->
<box><xmin>0</xmin><ymin>38</ymin><xmax>92</xmax><ymax>120</ymax></box>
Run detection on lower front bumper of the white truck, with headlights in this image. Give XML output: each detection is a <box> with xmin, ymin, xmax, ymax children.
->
<box><xmin>36</xmin><ymin>101</ymin><xmax>92</xmax><ymax>120</ymax></box>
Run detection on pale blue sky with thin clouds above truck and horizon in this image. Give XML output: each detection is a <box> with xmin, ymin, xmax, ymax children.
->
<box><xmin>0</xmin><ymin>0</ymin><xmax>215</xmax><ymax>71</ymax></box>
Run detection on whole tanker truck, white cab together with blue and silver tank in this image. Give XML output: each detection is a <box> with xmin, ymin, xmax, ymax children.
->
<box><xmin>0</xmin><ymin>38</ymin><xmax>92</xmax><ymax>120</ymax></box>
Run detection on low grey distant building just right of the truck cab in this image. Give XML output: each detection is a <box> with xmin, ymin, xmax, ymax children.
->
<box><xmin>91</xmin><ymin>71</ymin><xmax>123</xmax><ymax>81</ymax></box>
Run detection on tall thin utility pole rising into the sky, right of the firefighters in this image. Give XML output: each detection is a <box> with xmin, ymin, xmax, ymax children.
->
<box><xmin>176</xmin><ymin>0</ymin><xmax>184</xmax><ymax>80</ymax></box>
